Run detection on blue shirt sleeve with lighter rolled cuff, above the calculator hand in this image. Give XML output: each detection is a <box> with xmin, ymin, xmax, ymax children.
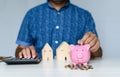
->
<box><xmin>16</xmin><ymin>12</ymin><xmax>33</xmax><ymax>46</ymax></box>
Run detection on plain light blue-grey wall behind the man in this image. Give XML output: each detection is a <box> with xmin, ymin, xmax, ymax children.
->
<box><xmin>0</xmin><ymin>0</ymin><xmax>120</xmax><ymax>58</ymax></box>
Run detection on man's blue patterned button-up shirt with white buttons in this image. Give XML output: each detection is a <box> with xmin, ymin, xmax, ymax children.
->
<box><xmin>16</xmin><ymin>1</ymin><xmax>97</xmax><ymax>57</ymax></box>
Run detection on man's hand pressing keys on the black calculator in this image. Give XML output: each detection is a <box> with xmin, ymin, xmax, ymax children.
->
<box><xmin>15</xmin><ymin>46</ymin><xmax>38</xmax><ymax>58</ymax></box>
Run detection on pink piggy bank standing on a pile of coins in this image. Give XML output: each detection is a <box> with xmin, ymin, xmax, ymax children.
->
<box><xmin>70</xmin><ymin>44</ymin><xmax>90</xmax><ymax>67</ymax></box>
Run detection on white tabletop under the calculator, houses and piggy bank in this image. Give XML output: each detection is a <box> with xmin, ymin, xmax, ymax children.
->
<box><xmin>0</xmin><ymin>58</ymin><xmax>120</xmax><ymax>77</ymax></box>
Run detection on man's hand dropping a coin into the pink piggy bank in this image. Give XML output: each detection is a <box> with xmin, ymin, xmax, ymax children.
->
<box><xmin>78</xmin><ymin>32</ymin><xmax>102</xmax><ymax>57</ymax></box>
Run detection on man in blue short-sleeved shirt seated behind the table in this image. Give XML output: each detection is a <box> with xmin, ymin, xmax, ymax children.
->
<box><xmin>16</xmin><ymin>0</ymin><xmax>102</xmax><ymax>58</ymax></box>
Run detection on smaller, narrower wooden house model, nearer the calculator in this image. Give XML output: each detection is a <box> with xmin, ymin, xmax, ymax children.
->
<box><xmin>42</xmin><ymin>43</ymin><xmax>53</xmax><ymax>61</ymax></box>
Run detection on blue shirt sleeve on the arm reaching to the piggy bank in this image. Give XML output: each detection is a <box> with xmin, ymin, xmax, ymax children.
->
<box><xmin>84</xmin><ymin>12</ymin><xmax>98</xmax><ymax>37</ymax></box>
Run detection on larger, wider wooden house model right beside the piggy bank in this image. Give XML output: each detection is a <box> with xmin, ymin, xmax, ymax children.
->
<box><xmin>56</xmin><ymin>42</ymin><xmax>70</xmax><ymax>61</ymax></box>
